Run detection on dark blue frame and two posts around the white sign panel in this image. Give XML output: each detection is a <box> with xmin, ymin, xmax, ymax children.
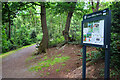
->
<box><xmin>81</xmin><ymin>8</ymin><xmax>111</xmax><ymax>80</ymax></box>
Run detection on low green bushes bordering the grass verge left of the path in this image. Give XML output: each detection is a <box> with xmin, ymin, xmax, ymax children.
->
<box><xmin>2</xmin><ymin>25</ymin><xmax>37</xmax><ymax>53</ymax></box>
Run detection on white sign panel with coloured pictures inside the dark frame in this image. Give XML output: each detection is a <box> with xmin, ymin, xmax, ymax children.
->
<box><xmin>83</xmin><ymin>20</ymin><xmax>104</xmax><ymax>45</ymax></box>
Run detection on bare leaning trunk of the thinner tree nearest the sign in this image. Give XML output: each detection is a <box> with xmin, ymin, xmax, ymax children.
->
<box><xmin>62</xmin><ymin>2</ymin><xmax>76</xmax><ymax>43</ymax></box>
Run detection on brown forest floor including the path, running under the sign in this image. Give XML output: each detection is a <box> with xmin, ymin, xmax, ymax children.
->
<box><xmin>2</xmin><ymin>44</ymin><xmax>109</xmax><ymax>78</ymax></box>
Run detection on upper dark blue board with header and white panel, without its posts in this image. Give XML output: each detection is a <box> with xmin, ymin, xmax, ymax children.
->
<box><xmin>81</xmin><ymin>9</ymin><xmax>109</xmax><ymax>47</ymax></box>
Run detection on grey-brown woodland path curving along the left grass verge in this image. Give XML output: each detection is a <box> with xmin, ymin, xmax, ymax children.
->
<box><xmin>2</xmin><ymin>45</ymin><xmax>40</xmax><ymax>78</ymax></box>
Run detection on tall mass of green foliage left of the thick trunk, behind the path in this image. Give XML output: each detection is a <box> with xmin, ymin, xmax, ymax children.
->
<box><xmin>2</xmin><ymin>2</ymin><xmax>42</xmax><ymax>53</ymax></box>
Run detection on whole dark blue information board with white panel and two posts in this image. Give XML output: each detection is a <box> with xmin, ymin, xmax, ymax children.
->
<box><xmin>81</xmin><ymin>8</ymin><xmax>111</xmax><ymax>80</ymax></box>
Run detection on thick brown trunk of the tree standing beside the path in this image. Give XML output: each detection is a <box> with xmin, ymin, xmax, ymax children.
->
<box><xmin>38</xmin><ymin>3</ymin><xmax>49</xmax><ymax>54</ymax></box>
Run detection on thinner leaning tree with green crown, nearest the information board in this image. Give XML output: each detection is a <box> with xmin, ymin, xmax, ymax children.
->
<box><xmin>51</xmin><ymin>0</ymin><xmax>85</xmax><ymax>43</ymax></box>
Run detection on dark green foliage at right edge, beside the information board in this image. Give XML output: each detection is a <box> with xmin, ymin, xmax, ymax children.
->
<box><xmin>99</xmin><ymin>2</ymin><xmax>120</xmax><ymax>75</ymax></box>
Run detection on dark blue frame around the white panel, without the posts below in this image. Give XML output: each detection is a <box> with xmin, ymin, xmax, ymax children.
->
<box><xmin>81</xmin><ymin>8</ymin><xmax>111</xmax><ymax>48</ymax></box>
